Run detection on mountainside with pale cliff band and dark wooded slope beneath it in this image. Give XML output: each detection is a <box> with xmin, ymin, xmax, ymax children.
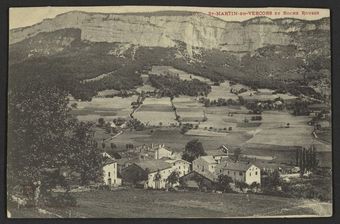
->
<box><xmin>9</xmin><ymin>12</ymin><xmax>330</xmax><ymax>100</ymax></box>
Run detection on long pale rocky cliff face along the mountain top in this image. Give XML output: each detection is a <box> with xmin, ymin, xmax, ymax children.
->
<box><xmin>9</xmin><ymin>12</ymin><xmax>329</xmax><ymax>55</ymax></box>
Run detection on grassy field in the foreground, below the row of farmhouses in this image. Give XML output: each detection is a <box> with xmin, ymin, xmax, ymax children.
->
<box><xmin>9</xmin><ymin>189</ymin><xmax>331</xmax><ymax>218</ymax></box>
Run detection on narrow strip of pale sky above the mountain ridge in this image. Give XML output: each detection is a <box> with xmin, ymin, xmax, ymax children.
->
<box><xmin>9</xmin><ymin>6</ymin><xmax>330</xmax><ymax>29</ymax></box>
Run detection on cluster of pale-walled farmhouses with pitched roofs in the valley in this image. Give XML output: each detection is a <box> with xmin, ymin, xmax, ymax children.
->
<box><xmin>103</xmin><ymin>145</ymin><xmax>261</xmax><ymax>189</ymax></box>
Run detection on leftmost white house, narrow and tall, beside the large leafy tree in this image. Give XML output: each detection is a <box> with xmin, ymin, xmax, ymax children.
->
<box><xmin>103</xmin><ymin>158</ymin><xmax>122</xmax><ymax>187</ymax></box>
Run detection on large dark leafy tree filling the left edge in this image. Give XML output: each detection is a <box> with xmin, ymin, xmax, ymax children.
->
<box><xmin>7</xmin><ymin>81</ymin><xmax>101</xmax><ymax>201</ymax></box>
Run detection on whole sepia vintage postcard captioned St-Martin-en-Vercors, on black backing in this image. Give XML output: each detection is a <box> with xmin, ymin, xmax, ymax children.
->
<box><xmin>7</xmin><ymin>6</ymin><xmax>333</xmax><ymax>218</ymax></box>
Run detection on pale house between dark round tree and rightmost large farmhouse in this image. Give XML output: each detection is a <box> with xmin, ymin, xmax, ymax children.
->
<box><xmin>192</xmin><ymin>155</ymin><xmax>228</xmax><ymax>180</ymax></box>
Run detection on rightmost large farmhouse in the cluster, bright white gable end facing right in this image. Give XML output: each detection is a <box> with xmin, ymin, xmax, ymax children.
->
<box><xmin>216</xmin><ymin>159</ymin><xmax>261</xmax><ymax>185</ymax></box>
